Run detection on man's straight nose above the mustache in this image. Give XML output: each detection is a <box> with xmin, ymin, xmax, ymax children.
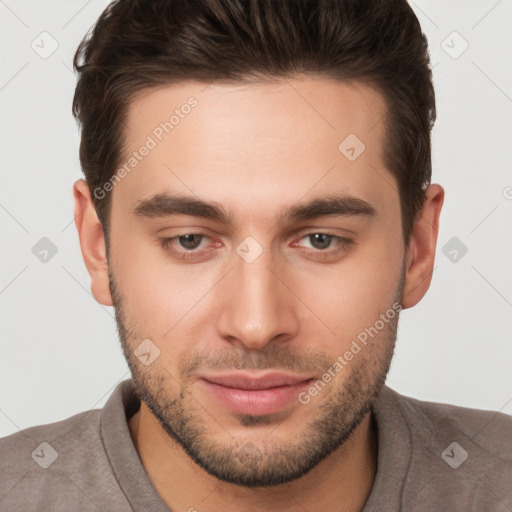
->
<box><xmin>216</xmin><ymin>245</ymin><xmax>299</xmax><ymax>350</ymax></box>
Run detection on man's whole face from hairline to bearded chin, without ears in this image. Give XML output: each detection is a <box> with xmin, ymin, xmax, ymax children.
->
<box><xmin>105</xmin><ymin>77</ymin><xmax>405</xmax><ymax>486</ymax></box>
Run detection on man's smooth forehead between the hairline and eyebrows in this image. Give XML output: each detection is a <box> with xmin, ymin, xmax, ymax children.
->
<box><xmin>113</xmin><ymin>77</ymin><xmax>398</xmax><ymax>222</ymax></box>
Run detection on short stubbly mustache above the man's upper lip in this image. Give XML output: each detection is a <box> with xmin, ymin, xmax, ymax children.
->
<box><xmin>178</xmin><ymin>346</ymin><xmax>334</xmax><ymax>378</ymax></box>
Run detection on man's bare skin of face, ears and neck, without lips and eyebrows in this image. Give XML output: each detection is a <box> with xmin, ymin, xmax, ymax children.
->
<box><xmin>74</xmin><ymin>76</ymin><xmax>444</xmax><ymax>512</ymax></box>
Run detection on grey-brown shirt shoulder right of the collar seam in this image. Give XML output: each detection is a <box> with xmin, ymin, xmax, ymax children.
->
<box><xmin>385</xmin><ymin>388</ymin><xmax>512</xmax><ymax>512</ymax></box>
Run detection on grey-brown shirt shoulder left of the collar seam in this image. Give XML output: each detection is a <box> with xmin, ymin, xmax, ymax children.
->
<box><xmin>0</xmin><ymin>410</ymin><xmax>126</xmax><ymax>510</ymax></box>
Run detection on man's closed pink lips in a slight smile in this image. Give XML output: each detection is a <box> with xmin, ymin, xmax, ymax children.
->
<box><xmin>200</xmin><ymin>371</ymin><xmax>314</xmax><ymax>416</ymax></box>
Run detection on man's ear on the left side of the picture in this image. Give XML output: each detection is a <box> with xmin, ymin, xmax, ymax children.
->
<box><xmin>73</xmin><ymin>180</ymin><xmax>113</xmax><ymax>306</ymax></box>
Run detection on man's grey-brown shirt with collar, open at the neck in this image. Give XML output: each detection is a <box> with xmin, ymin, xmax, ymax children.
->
<box><xmin>0</xmin><ymin>380</ymin><xmax>512</xmax><ymax>512</ymax></box>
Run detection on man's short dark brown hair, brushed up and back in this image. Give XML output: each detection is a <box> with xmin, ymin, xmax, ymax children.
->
<box><xmin>73</xmin><ymin>0</ymin><xmax>436</xmax><ymax>241</ymax></box>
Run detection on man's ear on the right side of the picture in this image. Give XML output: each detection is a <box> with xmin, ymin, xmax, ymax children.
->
<box><xmin>402</xmin><ymin>184</ymin><xmax>444</xmax><ymax>309</ymax></box>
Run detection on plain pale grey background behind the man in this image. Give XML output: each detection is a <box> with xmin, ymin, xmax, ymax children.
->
<box><xmin>0</xmin><ymin>0</ymin><xmax>512</xmax><ymax>435</ymax></box>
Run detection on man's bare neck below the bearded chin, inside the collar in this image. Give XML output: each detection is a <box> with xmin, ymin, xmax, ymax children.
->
<box><xmin>129</xmin><ymin>403</ymin><xmax>377</xmax><ymax>512</ymax></box>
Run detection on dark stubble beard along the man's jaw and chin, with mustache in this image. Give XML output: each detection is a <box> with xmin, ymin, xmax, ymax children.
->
<box><xmin>110</xmin><ymin>273</ymin><xmax>404</xmax><ymax>487</ymax></box>
